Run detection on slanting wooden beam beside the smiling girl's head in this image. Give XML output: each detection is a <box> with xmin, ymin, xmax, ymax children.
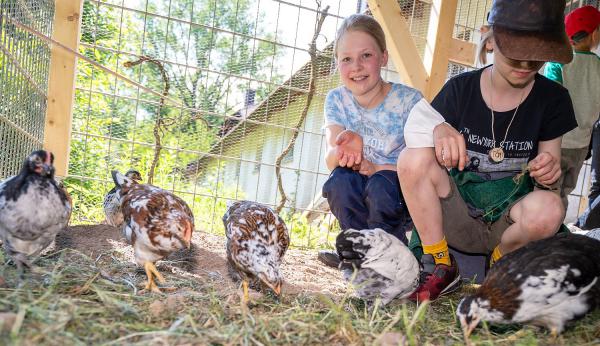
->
<box><xmin>368</xmin><ymin>0</ymin><xmax>426</xmax><ymax>92</ymax></box>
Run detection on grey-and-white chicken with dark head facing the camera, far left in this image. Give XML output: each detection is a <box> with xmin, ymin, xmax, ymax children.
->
<box><xmin>0</xmin><ymin>150</ymin><xmax>72</xmax><ymax>274</ymax></box>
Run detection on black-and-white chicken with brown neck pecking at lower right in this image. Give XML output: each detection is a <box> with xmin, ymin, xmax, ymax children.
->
<box><xmin>456</xmin><ymin>233</ymin><xmax>600</xmax><ymax>337</ymax></box>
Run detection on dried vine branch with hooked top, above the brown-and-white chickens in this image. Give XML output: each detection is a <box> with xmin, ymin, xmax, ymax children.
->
<box><xmin>123</xmin><ymin>56</ymin><xmax>170</xmax><ymax>184</ymax></box>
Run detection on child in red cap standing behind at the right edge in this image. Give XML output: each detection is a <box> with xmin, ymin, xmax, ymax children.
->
<box><xmin>544</xmin><ymin>6</ymin><xmax>600</xmax><ymax>208</ymax></box>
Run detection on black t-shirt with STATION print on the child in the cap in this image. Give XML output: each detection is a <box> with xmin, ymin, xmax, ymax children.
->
<box><xmin>431</xmin><ymin>68</ymin><xmax>577</xmax><ymax>178</ymax></box>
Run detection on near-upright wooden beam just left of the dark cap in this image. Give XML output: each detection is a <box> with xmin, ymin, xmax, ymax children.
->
<box><xmin>423</xmin><ymin>0</ymin><xmax>458</xmax><ymax>101</ymax></box>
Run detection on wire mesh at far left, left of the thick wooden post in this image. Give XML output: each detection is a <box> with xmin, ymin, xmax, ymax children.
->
<box><xmin>0</xmin><ymin>0</ymin><xmax>54</xmax><ymax>179</ymax></box>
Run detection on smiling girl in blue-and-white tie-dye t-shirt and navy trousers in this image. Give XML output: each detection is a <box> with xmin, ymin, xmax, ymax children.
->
<box><xmin>318</xmin><ymin>14</ymin><xmax>443</xmax><ymax>267</ymax></box>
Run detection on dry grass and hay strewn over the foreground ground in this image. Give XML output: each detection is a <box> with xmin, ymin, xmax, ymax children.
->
<box><xmin>0</xmin><ymin>250</ymin><xmax>600</xmax><ymax>345</ymax></box>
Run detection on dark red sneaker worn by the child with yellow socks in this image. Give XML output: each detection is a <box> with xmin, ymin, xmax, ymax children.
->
<box><xmin>408</xmin><ymin>254</ymin><xmax>460</xmax><ymax>302</ymax></box>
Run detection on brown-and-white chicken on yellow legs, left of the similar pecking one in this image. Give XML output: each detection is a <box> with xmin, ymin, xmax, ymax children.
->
<box><xmin>112</xmin><ymin>171</ymin><xmax>194</xmax><ymax>292</ymax></box>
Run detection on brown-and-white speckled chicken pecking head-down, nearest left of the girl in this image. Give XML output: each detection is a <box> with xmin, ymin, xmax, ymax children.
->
<box><xmin>223</xmin><ymin>201</ymin><xmax>290</xmax><ymax>305</ymax></box>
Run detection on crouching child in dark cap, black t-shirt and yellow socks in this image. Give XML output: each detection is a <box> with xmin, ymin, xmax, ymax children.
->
<box><xmin>397</xmin><ymin>0</ymin><xmax>577</xmax><ymax>301</ymax></box>
